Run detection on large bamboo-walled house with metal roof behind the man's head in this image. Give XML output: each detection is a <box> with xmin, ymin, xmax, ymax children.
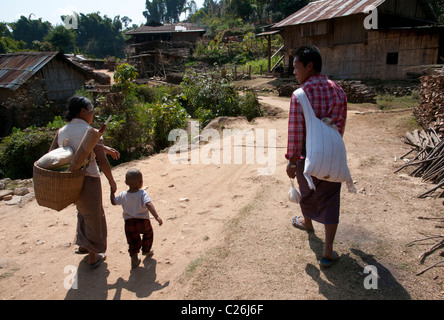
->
<box><xmin>272</xmin><ymin>0</ymin><xmax>444</xmax><ymax>80</ymax></box>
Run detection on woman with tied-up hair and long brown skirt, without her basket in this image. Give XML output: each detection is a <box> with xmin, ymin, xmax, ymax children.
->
<box><xmin>50</xmin><ymin>96</ymin><xmax>117</xmax><ymax>268</ymax></box>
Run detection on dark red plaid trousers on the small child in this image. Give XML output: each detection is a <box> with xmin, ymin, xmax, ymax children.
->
<box><xmin>125</xmin><ymin>219</ymin><xmax>154</xmax><ymax>256</ymax></box>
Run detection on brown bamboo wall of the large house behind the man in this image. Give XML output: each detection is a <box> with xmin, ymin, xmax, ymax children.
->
<box><xmin>284</xmin><ymin>19</ymin><xmax>440</xmax><ymax>80</ymax></box>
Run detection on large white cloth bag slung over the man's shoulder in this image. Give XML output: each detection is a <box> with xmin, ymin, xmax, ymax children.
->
<box><xmin>294</xmin><ymin>88</ymin><xmax>356</xmax><ymax>193</ymax></box>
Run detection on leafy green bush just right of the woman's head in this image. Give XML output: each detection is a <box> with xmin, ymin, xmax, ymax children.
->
<box><xmin>94</xmin><ymin>84</ymin><xmax>188</xmax><ymax>160</ymax></box>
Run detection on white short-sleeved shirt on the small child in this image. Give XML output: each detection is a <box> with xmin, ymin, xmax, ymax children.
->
<box><xmin>114</xmin><ymin>190</ymin><xmax>151</xmax><ymax>220</ymax></box>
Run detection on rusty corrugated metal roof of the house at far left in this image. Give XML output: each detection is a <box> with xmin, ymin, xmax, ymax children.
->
<box><xmin>0</xmin><ymin>52</ymin><xmax>57</xmax><ymax>90</ymax></box>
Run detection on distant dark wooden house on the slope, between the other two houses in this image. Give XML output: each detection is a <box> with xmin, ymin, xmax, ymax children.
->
<box><xmin>125</xmin><ymin>23</ymin><xmax>205</xmax><ymax>77</ymax></box>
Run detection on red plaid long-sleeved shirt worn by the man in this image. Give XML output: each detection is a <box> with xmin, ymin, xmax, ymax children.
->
<box><xmin>285</xmin><ymin>75</ymin><xmax>347</xmax><ymax>160</ymax></box>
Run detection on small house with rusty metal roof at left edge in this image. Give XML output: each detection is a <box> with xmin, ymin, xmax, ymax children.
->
<box><xmin>0</xmin><ymin>52</ymin><xmax>93</xmax><ymax>136</ymax></box>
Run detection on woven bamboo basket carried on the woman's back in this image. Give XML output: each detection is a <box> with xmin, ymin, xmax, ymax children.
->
<box><xmin>33</xmin><ymin>163</ymin><xmax>85</xmax><ymax>211</ymax></box>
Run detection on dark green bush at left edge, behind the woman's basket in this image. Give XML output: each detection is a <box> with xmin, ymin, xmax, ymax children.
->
<box><xmin>0</xmin><ymin>127</ymin><xmax>56</xmax><ymax>180</ymax></box>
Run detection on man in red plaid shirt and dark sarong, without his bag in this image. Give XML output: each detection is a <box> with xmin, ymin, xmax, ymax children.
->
<box><xmin>285</xmin><ymin>46</ymin><xmax>347</xmax><ymax>267</ymax></box>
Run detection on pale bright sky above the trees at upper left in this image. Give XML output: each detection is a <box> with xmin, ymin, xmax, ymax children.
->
<box><xmin>0</xmin><ymin>0</ymin><xmax>204</xmax><ymax>26</ymax></box>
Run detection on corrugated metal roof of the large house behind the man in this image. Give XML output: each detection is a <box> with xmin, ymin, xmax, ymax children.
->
<box><xmin>273</xmin><ymin>0</ymin><xmax>385</xmax><ymax>28</ymax></box>
